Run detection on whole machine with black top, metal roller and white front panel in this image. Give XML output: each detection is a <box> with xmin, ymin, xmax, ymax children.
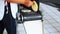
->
<box><xmin>6</xmin><ymin>0</ymin><xmax>42</xmax><ymax>34</ymax></box>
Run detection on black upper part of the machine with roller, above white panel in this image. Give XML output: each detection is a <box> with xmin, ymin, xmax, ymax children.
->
<box><xmin>17</xmin><ymin>0</ymin><xmax>42</xmax><ymax>22</ymax></box>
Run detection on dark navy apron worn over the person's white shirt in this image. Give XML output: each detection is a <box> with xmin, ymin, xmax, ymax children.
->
<box><xmin>0</xmin><ymin>4</ymin><xmax>16</xmax><ymax>34</ymax></box>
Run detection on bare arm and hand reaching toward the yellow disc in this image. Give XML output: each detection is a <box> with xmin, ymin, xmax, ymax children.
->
<box><xmin>6</xmin><ymin>0</ymin><xmax>33</xmax><ymax>7</ymax></box>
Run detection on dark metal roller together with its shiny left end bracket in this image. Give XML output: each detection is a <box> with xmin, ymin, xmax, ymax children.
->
<box><xmin>17</xmin><ymin>12</ymin><xmax>42</xmax><ymax>23</ymax></box>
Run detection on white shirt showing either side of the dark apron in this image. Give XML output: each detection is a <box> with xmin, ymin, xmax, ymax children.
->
<box><xmin>0</xmin><ymin>0</ymin><xmax>18</xmax><ymax>20</ymax></box>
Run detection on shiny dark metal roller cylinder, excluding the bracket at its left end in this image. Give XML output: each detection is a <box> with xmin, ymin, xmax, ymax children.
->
<box><xmin>23</xmin><ymin>12</ymin><xmax>42</xmax><ymax>21</ymax></box>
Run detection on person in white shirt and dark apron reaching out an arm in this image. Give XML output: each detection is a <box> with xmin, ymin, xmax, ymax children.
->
<box><xmin>0</xmin><ymin>0</ymin><xmax>33</xmax><ymax>34</ymax></box>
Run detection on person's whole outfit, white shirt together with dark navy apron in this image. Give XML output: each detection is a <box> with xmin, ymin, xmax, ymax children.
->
<box><xmin>0</xmin><ymin>0</ymin><xmax>18</xmax><ymax>34</ymax></box>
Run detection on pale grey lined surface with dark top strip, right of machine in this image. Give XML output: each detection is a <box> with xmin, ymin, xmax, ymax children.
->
<box><xmin>40</xmin><ymin>0</ymin><xmax>60</xmax><ymax>34</ymax></box>
